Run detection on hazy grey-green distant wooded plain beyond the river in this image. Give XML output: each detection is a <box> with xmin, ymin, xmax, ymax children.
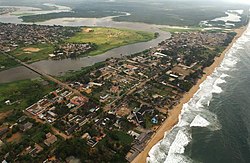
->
<box><xmin>18</xmin><ymin>0</ymin><xmax>250</xmax><ymax>26</ymax></box>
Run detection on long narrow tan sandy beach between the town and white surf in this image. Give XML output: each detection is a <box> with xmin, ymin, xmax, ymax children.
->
<box><xmin>132</xmin><ymin>26</ymin><xmax>247</xmax><ymax>163</ymax></box>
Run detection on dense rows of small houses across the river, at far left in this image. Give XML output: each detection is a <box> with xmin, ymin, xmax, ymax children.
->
<box><xmin>0</xmin><ymin>23</ymin><xmax>80</xmax><ymax>52</ymax></box>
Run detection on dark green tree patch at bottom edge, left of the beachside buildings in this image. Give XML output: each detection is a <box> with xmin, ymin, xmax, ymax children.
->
<box><xmin>55</xmin><ymin>131</ymin><xmax>133</xmax><ymax>163</ymax></box>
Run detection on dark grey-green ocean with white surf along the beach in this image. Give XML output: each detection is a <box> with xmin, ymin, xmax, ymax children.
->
<box><xmin>147</xmin><ymin>24</ymin><xmax>250</xmax><ymax>163</ymax></box>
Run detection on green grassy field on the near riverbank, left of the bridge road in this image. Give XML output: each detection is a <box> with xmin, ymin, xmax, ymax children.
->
<box><xmin>0</xmin><ymin>79</ymin><xmax>54</xmax><ymax>112</ymax></box>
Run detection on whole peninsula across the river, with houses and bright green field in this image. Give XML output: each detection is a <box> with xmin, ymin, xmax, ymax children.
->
<box><xmin>0</xmin><ymin>23</ymin><xmax>154</xmax><ymax>65</ymax></box>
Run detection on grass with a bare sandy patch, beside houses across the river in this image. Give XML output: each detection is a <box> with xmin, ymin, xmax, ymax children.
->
<box><xmin>10</xmin><ymin>44</ymin><xmax>54</xmax><ymax>62</ymax></box>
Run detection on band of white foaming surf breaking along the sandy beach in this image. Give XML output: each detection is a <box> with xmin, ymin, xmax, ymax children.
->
<box><xmin>147</xmin><ymin>27</ymin><xmax>250</xmax><ymax>163</ymax></box>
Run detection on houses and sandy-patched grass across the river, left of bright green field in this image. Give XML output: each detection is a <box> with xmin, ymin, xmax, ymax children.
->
<box><xmin>0</xmin><ymin>23</ymin><xmax>85</xmax><ymax>62</ymax></box>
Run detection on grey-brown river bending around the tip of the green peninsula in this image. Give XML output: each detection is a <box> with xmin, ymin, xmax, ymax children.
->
<box><xmin>0</xmin><ymin>4</ymin><xmax>171</xmax><ymax>83</ymax></box>
